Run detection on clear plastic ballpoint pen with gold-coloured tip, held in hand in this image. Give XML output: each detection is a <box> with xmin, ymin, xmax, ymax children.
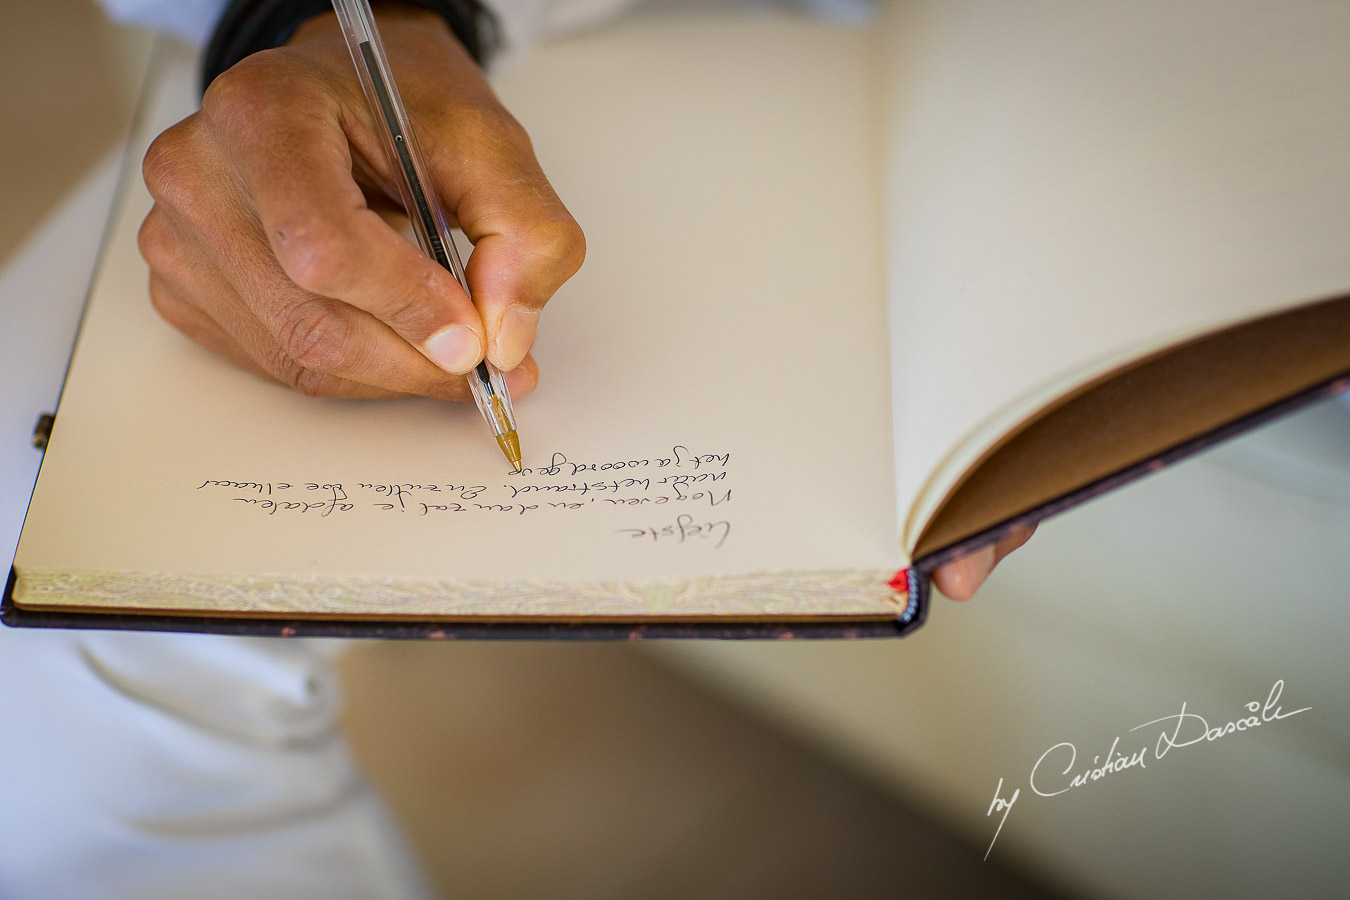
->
<box><xmin>332</xmin><ymin>0</ymin><xmax>522</xmax><ymax>472</ymax></box>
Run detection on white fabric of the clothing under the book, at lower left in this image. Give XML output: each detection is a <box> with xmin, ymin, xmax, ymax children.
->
<box><xmin>0</xmin><ymin>155</ymin><xmax>431</xmax><ymax>900</ymax></box>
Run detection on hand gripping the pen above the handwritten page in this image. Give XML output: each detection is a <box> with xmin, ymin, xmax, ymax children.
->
<box><xmin>140</xmin><ymin>7</ymin><xmax>585</xmax><ymax>399</ymax></box>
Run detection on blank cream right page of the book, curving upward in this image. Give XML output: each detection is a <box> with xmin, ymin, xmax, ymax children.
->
<box><xmin>884</xmin><ymin>0</ymin><xmax>1350</xmax><ymax>546</ymax></box>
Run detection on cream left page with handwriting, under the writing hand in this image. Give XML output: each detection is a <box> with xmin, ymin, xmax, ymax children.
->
<box><xmin>15</xmin><ymin>13</ymin><xmax>905</xmax><ymax>615</ymax></box>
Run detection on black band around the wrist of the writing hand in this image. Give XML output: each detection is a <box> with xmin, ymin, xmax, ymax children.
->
<box><xmin>201</xmin><ymin>0</ymin><xmax>497</xmax><ymax>90</ymax></box>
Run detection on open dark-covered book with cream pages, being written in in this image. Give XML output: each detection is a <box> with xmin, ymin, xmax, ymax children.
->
<box><xmin>5</xmin><ymin>0</ymin><xmax>1350</xmax><ymax>636</ymax></box>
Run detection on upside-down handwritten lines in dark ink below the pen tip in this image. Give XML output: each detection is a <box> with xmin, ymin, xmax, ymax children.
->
<box><xmin>196</xmin><ymin>444</ymin><xmax>732</xmax><ymax>549</ymax></box>
